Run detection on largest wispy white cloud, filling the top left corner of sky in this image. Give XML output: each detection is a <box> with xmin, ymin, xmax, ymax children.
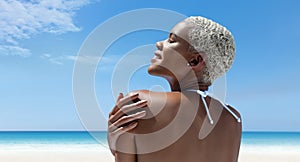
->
<box><xmin>0</xmin><ymin>0</ymin><xmax>89</xmax><ymax>44</ymax></box>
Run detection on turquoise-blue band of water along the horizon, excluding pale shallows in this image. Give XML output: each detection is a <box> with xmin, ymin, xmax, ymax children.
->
<box><xmin>0</xmin><ymin>132</ymin><xmax>300</xmax><ymax>146</ymax></box>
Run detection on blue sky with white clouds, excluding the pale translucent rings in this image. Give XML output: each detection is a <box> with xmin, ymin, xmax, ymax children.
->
<box><xmin>0</xmin><ymin>0</ymin><xmax>300</xmax><ymax>131</ymax></box>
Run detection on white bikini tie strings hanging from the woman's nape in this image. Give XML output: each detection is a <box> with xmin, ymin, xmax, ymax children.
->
<box><xmin>187</xmin><ymin>89</ymin><xmax>241</xmax><ymax>125</ymax></box>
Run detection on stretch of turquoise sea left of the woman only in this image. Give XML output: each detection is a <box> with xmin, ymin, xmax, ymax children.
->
<box><xmin>0</xmin><ymin>131</ymin><xmax>109</xmax><ymax>151</ymax></box>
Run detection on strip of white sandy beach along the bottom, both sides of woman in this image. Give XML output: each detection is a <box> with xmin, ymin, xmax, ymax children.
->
<box><xmin>0</xmin><ymin>149</ymin><xmax>300</xmax><ymax>162</ymax></box>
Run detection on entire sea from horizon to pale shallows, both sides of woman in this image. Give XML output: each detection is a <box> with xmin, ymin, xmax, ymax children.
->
<box><xmin>0</xmin><ymin>131</ymin><xmax>300</xmax><ymax>154</ymax></box>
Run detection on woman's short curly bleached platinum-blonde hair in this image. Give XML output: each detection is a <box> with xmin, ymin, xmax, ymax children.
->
<box><xmin>185</xmin><ymin>16</ymin><xmax>235</xmax><ymax>84</ymax></box>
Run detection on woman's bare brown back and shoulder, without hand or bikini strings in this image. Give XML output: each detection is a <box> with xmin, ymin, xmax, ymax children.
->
<box><xmin>129</xmin><ymin>90</ymin><xmax>241</xmax><ymax>162</ymax></box>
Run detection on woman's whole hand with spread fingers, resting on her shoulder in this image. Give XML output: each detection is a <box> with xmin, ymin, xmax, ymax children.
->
<box><xmin>107</xmin><ymin>93</ymin><xmax>147</xmax><ymax>155</ymax></box>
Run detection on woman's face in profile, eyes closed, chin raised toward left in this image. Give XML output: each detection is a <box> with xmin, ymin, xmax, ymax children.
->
<box><xmin>148</xmin><ymin>21</ymin><xmax>195</xmax><ymax>80</ymax></box>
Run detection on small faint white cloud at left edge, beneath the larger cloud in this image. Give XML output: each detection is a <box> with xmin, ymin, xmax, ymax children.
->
<box><xmin>0</xmin><ymin>45</ymin><xmax>31</xmax><ymax>57</ymax></box>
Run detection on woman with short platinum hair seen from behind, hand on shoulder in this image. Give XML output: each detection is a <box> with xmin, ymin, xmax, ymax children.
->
<box><xmin>108</xmin><ymin>16</ymin><xmax>241</xmax><ymax>162</ymax></box>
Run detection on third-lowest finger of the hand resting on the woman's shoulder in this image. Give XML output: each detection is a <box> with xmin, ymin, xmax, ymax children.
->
<box><xmin>109</xmin><ymin>100</ymin><xmax>147</xmax><ymax>123</ymax></box>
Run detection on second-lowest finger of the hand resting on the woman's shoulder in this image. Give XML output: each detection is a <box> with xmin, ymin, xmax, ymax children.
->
<box><xmin>108</xmin><ymin>111</ymin><xmax>146</xmax><ymax>132</ymax></box>
